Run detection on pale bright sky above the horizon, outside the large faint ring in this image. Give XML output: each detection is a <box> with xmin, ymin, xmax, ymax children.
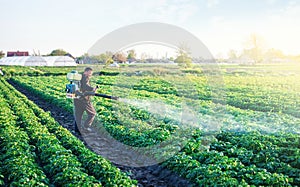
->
<box><xmin>0</xmin><ymin>0</ymin><xmax>300</xmax><ymax>57</ymax></box>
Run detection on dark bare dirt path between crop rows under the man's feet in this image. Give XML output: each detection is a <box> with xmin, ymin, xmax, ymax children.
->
<box><xmin>8</xmin><ymin>81</ymin><xmax>191</xmax><ymax>187</ymax></box>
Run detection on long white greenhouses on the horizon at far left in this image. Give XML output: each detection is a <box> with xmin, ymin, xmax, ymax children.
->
<box><xmin>0</xmin><ymin>56</ymin><xmax>76</xmax><ymax>66</ymax></box>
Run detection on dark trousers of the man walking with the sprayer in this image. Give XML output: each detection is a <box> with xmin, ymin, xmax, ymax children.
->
<box><xmin>74</xmin><ymin>99</ymin><xmax>96</xmax><ymax>131</ymax></box>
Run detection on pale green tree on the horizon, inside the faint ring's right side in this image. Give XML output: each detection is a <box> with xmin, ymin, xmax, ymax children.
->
<box><xmin>175</xmin><ymin>44</ymin><xmax>192</xmax><ymax>68</ymax></box>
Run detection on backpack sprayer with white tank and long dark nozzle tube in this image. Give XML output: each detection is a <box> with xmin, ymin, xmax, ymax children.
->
<box><xmin>66</xmin><ymin>70</ymin><xmax>119</xmax><ymax>100</ymax></box>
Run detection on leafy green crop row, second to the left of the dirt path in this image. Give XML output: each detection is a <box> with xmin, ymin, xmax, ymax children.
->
<box><xmin>0</xmin><ymin>79</ymin><xmax>101</xmax><ymax>186</ymax></box>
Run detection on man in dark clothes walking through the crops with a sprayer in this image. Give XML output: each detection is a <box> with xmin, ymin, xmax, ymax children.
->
<box><xmin>74</xmin><ymin>67</ymin><xmax>97</xmax><ymax>132</ymax></box>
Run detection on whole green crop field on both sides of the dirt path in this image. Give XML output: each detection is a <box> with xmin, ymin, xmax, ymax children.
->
<box><xmin>0</xmin><ymin>64</ymin><xmax>300</xmax><ymax>186</ymax></box>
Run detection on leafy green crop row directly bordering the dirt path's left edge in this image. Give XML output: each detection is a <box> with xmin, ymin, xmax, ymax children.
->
<box><xmin>3</xmin><ymin>79</ymin><xmax>136</xmax><ymax>186</ymax></box>
